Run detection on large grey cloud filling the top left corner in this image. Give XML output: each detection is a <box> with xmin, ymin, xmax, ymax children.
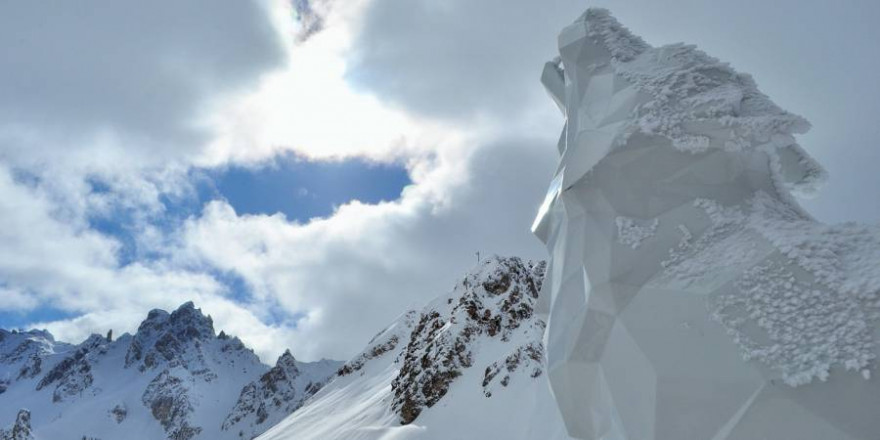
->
<box><xmin>0</xmin><ymin>0</ymin><xmax>284</xmax><ymax>166</ymax></box>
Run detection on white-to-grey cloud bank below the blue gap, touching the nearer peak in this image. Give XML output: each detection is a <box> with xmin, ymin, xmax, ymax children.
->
<box><xmin>175</xmin><ymin>139</ymin><xmax>553</xmax><ymax>358</ymax></box>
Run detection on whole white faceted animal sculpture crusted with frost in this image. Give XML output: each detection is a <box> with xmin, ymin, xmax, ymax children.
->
<box><xmin>533</xmin><ymin>9</ymin><xmax>880</xmax><ymax>440</ymax></box>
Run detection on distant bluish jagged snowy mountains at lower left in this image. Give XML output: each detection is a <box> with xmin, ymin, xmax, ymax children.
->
<box><xmin>0</xmin><ymin>303</ymin><xmax>342</xmax><ymax>440</ymax></box>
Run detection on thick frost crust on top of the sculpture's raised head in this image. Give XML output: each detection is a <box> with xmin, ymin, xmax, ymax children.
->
<box><xmin>557</xmin><ymin>8</ymin><xmax>827</xmax><ymax>196</ymax></box>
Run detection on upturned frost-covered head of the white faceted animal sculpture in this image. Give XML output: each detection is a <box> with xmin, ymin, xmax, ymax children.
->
<box><xmin>533</xmin><ymin>9</ymin><xmax>825</xmax><ymax>284</ymax></box>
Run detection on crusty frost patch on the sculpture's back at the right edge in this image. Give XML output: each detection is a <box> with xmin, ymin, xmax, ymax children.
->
<box><xmin>663</xmin><ymin>192</ymin><xmax>880</xmax><ymax>386</ymax></box>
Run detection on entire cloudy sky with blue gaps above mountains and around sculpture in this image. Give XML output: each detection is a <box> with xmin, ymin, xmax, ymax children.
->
<box><xmin>0</xmin><ymin>0</ymin><xmax>880</xmax><ymax>363</ymax></box>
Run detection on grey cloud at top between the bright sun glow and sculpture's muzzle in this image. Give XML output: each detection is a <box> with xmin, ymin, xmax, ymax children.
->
<box><xmin>347</xmin><ymin>0</ymin><xmax>586</xmax><ymax>124</ymax></box>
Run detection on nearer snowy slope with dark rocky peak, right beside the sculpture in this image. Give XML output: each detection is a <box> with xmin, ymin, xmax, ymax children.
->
<box><xmin>259</xmin><ymin>257</ymin><xmax>568</xmax><ymax>440</ymax></box>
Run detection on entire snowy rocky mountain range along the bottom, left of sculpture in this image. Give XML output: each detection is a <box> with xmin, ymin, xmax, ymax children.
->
<box><xmin>0</xmin><ymin>257</ymin><xmax>568</xmax><ymax>440</ymax></box>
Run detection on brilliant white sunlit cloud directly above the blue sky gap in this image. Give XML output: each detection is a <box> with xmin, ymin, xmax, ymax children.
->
<box><xmin>200</xmin><ymin>0</ymin><xmax>456</xmax><ymax>165</ymax></box>
